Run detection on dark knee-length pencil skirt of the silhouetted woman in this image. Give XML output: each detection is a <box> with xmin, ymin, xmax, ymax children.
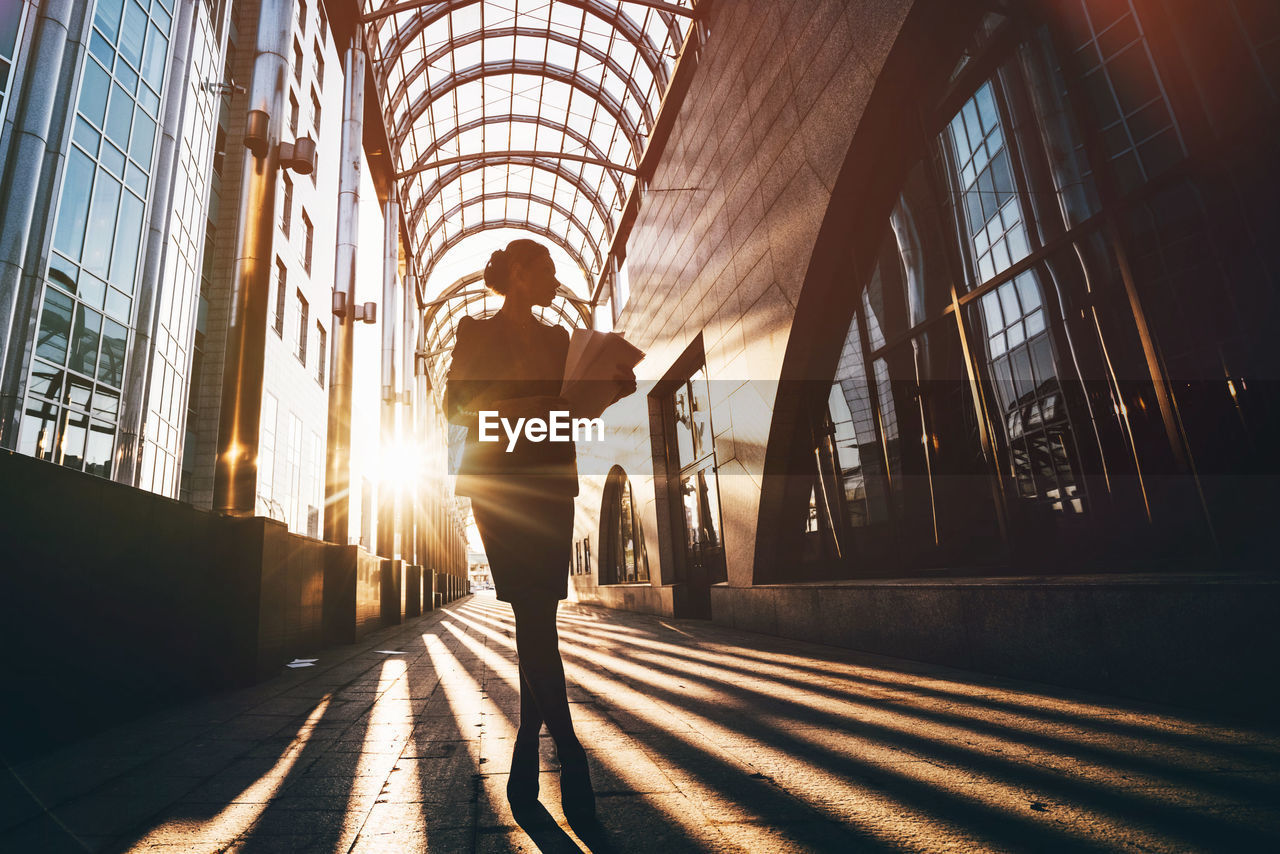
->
<box><xmin>471</xmin><ymin>483</ymin><xmax>573</xmax><ymax>602</ymax></box>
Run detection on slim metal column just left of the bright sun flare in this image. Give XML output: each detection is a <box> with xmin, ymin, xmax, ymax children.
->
<box><xmin>324</xmin><ymin>32</ymin><xmax>370</xmax><ymax>545</ymax></box>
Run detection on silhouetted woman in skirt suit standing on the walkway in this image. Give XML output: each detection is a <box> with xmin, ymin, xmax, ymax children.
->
<box><xmin>444</xmin><ymin>239</ymin><xmax>635</xmax><ymax>817</ymax></box>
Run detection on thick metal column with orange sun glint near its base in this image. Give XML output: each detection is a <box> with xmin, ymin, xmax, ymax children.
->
<box><xmin>214</xmin><ymin>0</ymin><xmax>293</xmax><ymax>516</ymax></box>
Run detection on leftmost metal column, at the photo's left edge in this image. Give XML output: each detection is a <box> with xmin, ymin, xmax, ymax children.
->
<box><xmin>0</xmin><ymin>0</ymin><xmax>76</xmax><ymax>448</ymax></box>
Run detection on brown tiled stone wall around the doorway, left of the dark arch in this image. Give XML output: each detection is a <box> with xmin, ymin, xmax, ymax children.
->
<box><xmin>575</xmin><ymin>0</ymin><xmax>910</xmax><ymax>586</ymax></box>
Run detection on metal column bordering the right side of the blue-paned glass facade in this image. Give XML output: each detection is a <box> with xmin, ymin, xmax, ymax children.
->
<box><xmin>115</xmin><ymin>3</ymin><xmax>196</xmax><ymax>483</ymax></box>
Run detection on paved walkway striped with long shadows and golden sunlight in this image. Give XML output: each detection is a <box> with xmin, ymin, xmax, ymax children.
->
<box><xmin>0</xmin><ymin>595</ymin><xmax>1280</xmax><ymax>854</ymax></box>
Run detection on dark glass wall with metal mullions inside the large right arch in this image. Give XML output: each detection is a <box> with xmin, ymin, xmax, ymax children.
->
<box><xmin>800</xmin><ymin>0</ymin><xmax>1280</xmax><ymax>577</ymax></box>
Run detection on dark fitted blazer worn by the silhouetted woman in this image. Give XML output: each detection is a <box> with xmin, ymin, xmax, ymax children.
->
<box><xmin>444</xmin><ymin>315</ymin><xmax>577</xmax><ymax>495</ymax></box>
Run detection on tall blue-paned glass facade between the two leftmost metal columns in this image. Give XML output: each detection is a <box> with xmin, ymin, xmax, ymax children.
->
<box><xmin>18</xmin><ymin>0</ymin><xmax>180</xmax><ymax>476</ymax></box>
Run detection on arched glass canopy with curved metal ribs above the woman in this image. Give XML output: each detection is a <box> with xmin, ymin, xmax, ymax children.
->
<box><xmin>362</xmin><ymin>0</ymin><xmax>694</xmax><ymax>286</ymax></box>
